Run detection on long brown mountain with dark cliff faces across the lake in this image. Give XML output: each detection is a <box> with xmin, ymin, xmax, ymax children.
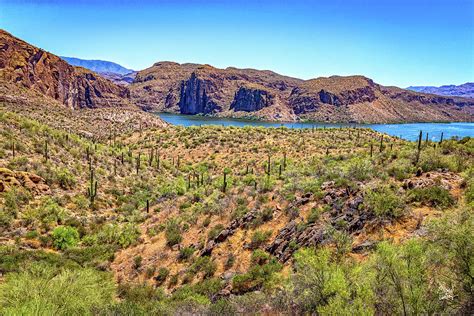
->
<box><xmin>130</xmin><ymin>62</ymin><xmax>474</xmax><ymax>123</ymax></box>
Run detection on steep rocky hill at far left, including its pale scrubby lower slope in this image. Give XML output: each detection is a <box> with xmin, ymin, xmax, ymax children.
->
<box><xmin>0</xmin><ymin>30</ymin><xmax>167</xmax><ymax>139</ymax></box>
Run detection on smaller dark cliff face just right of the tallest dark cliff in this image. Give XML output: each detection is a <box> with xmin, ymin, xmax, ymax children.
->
<box><xmin>230</xmin><ymin>87</ymin><xmax>274</xmax><ymax>112</ymax></box>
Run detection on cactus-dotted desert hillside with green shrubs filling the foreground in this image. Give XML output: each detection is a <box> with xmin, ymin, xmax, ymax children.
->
<box><xmin>0</xmin><ymin>106</ymin><xmax>474</xmax><ymax>315</ymax></box>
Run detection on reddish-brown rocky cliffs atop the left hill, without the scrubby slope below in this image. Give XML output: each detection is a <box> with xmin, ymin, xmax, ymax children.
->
<box><xmin>0</xmin><ymin>30</ymin><xmax>130</xmax><ymax>109</ymax></box>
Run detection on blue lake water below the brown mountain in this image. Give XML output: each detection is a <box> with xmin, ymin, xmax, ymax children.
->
<box><xmin>157</xmin><ymin>113</ymin><xmax>474</xmax><ymax>141</ymax></box>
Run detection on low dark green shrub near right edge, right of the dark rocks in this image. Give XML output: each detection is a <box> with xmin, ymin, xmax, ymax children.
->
<box><xmin>408</xmin><ymin>186</ymin><xmax>455</xmax><ymax>209</ymax></box>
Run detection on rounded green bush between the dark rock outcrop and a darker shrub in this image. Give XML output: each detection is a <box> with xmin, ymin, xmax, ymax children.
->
<box><xmin>364</xmin><ymin>186</ymin><xmax>405</xmax><ymax>218</ymax></box>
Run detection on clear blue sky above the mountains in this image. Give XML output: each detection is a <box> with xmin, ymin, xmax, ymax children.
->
<box><xmin>0</xmin><ymin>0</ymin><xmax>474</xmax><ymax>87</ymax></box>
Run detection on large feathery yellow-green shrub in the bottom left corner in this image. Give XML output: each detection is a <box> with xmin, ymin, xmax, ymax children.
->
<box><xmin>0</xmin><ymin>264</ymin><xmax>115</xmax><ymax>315</ymax></box>
